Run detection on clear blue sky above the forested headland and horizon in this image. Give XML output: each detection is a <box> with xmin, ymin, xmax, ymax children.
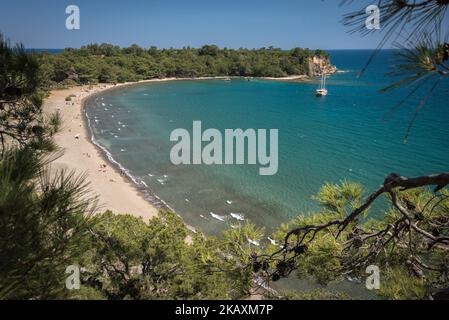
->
<box><xmin>0</xmin><ymin>0</ymin><xmax>380</xmax><ymax>49</ymax></box>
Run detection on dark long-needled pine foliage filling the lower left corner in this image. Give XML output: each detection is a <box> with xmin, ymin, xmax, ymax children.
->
<box><xmin>0</xmin><ymin>148</ymin><xmax>96</xmax><ymax>299</ymax></box>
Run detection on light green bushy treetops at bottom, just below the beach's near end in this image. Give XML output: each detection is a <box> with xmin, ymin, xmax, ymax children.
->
<box><xmin>73</xmin><ymin>212</ymin><xmax>260</xmax><ymax>300</ymax></box>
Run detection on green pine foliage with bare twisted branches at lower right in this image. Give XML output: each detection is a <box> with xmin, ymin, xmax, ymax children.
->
<box><xmin>256</xmin><ymin>181</ymin><xmax>449</xmax><ymax>299</ymax></box>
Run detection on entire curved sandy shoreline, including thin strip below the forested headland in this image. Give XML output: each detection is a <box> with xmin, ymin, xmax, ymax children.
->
<box><xmin>44</xmin><ymin>76</ymin><xmax>316</xmax><ymax>224</ymax></box>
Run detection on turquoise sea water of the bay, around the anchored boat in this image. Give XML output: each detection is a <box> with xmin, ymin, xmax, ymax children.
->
<box><xmin>87</xmin><ymin>51</ymin><xmax>449</xmax><ymax>233</ymax></box>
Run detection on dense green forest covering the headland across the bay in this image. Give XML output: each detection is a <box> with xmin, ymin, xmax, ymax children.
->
<box><xmin>40</xmin><ymin>44</ymin><xmax>328</xmax><ymax>86</ymax></box>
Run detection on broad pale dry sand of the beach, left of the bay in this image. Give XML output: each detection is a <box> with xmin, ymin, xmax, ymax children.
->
<box><xmin>44</xmin><ymin>84</ymin><xmax>164</xmax><ymax>220</ymax></box>
